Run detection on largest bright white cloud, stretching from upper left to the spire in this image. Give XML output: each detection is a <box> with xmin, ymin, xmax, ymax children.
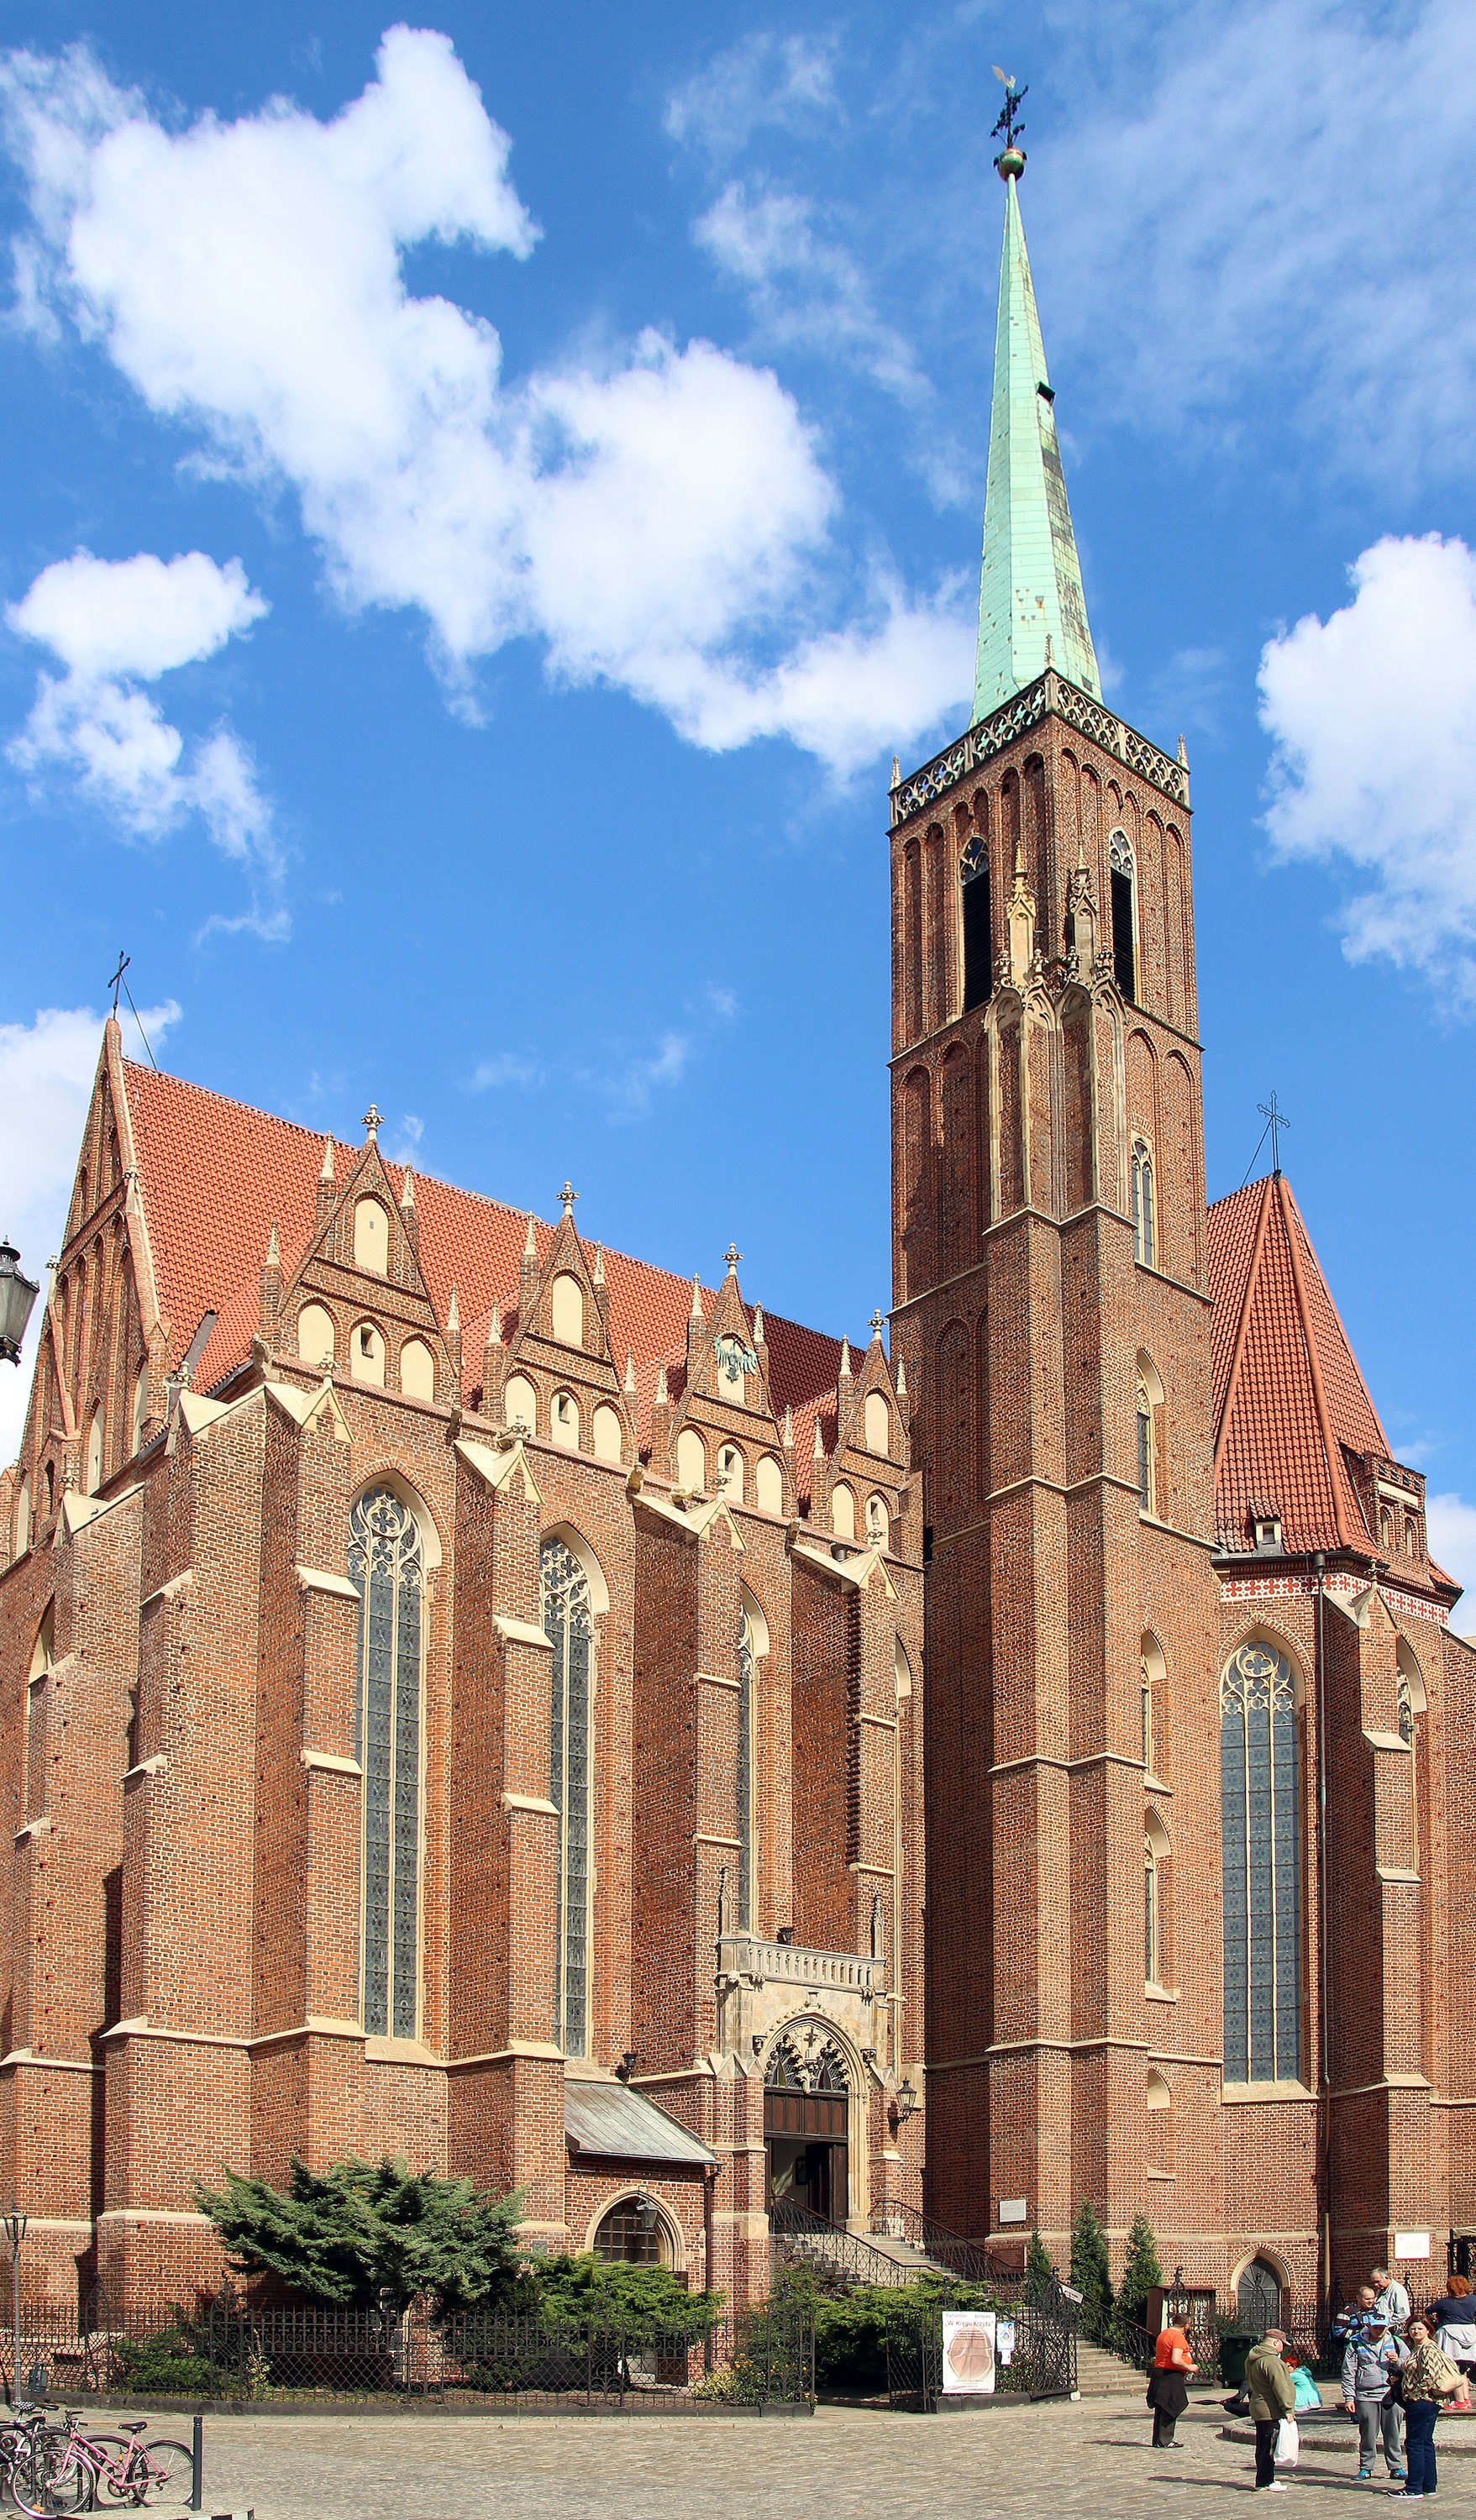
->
<box><xmin>0</xmin><ymin>28</ymin><xmax>964</xmax><ymax>776</ymax></box>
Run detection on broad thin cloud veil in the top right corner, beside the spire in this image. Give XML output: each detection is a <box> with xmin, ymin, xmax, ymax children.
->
<box><xmin>1032</xmin><ymin>0</ymin><xmax>1476</xmax><ymax>491</ymax></box>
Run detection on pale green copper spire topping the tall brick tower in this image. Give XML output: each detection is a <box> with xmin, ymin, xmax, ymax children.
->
<box><xmin>974</xmin><ymin>164</ymin><xmax>1100</xmax><ymax>718</ymax></box>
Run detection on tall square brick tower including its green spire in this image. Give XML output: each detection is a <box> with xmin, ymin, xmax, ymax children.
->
<box><xmin>891</xmin><ymin>134</ymin><xmax>1221</xmax><ymax>2258</ymax></box>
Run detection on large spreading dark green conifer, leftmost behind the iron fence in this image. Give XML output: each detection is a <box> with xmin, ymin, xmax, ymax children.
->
<box><xmin>194</xmin><ymin>2155</ymin><xmax>522</xmax><ymax>2311</ymax></box>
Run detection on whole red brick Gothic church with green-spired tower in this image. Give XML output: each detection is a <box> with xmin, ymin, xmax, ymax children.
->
<box><xmin>0</xmin><ymin>123</ymin><xmax>1476</xmax><ymax>2318</ymax></box>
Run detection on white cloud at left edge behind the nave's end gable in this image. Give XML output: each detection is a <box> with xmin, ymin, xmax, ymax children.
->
<box><xmin>0</xmin><ymin>998</ymin><xmax>179</xmax><ymax>1462</ymax></box>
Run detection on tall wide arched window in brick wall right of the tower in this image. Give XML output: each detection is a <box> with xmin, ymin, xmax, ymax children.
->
<box><xmin>1219</xmin><ymin>1643</ymin><xmax>1302</xmax><ymax>2082</ymax></box>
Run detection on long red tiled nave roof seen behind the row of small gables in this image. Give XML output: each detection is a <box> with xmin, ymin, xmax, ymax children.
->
<box><xmin>123</xmin><ymin>1061</ymin><xmax>841</xmax><ymax>1449</ymax></box>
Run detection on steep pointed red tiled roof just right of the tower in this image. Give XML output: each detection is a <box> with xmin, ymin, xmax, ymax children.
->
<box><xmin>1209</xmin><ymin>1174</ymin><xmax>1390</xmax><ymax>1552</ymax></box>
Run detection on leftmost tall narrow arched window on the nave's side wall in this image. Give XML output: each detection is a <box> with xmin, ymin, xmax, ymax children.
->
<box><xmin>348</xmin><ymin>1487</ymin><xmax>426</xmax><ymax>2039</ymax></box>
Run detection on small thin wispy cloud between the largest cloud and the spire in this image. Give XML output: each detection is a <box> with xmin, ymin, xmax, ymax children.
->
<box><xmin>696</xmin><ymin>184</ymin><xmax>929</xmax><ymax>403</ymax></box>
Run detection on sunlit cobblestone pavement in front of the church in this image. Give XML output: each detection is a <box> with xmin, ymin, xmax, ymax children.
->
<box><xmin>204</xmin><ymin>2399</ymin><xmax>1476</xmax><ymax>2520</ymax></box>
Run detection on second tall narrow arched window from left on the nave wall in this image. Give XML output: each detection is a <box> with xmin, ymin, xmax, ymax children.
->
<box><xmin>539</xmin><ymin>1540</ymin><xmax>595</xmax><ymax>2056</ymax></box>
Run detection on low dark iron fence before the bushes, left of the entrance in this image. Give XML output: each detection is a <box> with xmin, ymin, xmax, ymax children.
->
<box><xmin>0</xmin><ymin>2298</ymin><xmax>813</xmax><ymax>2414</ymax></box>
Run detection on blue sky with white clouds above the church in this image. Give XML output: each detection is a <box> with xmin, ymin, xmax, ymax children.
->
<box><xmin>0</xmin><ymin>0</ymin><xmax>1476</xmax><ymax>1583</ymax></box>
